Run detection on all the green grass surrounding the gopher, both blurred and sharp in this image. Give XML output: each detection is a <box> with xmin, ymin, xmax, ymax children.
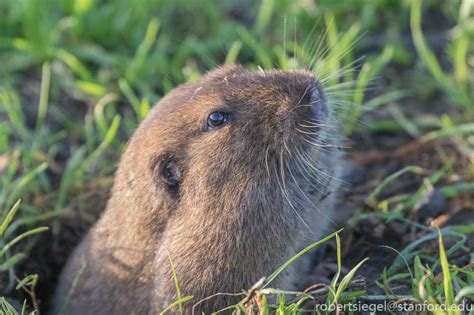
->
<box><xmin>0</xmin><ymin>0</ymin><xmax>474</xmax><ymax>314</ymax></box>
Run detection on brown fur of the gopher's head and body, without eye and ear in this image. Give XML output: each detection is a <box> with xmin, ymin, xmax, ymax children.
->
<box><xmin>54</xmin><ymin>66</ymin><xmax>338</xmax><ymax>314</ymax></box>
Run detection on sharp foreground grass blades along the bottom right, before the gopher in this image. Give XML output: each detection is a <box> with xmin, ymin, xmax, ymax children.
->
<box><xmin>161</xmin><ymin>221</ymin><xmax>474</xmax><ymax>315</ymax></box>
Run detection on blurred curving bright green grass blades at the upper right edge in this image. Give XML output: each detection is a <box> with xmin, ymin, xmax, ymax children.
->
<box><xmin>410</xmin><ymin>0</ymin><xmax>474</xmax><ymax>169</ymax></box>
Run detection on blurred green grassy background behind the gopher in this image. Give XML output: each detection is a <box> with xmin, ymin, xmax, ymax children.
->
<box><xmin>0</xmin><ymin>0</ymin><xmax>474</xmax><ymax>314</ymax></box>
